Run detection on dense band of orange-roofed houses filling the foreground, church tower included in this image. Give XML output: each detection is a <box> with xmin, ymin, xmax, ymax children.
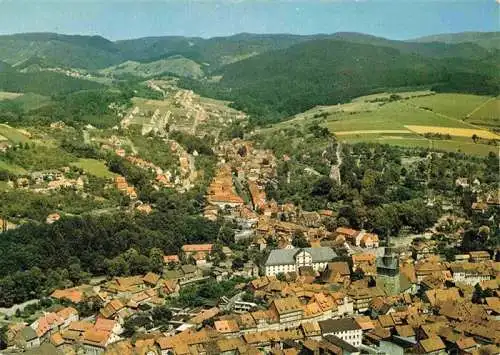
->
<box><xmin>4</xmin><ymin>230</ymin><xmax>500</xmax><ymax>355</ymax></box>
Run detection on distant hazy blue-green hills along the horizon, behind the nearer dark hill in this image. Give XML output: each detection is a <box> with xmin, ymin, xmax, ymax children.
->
<box><xmin>0</xmin><ymin>32</ymin><xmax>500</xmax><ymax>72</ymax></box>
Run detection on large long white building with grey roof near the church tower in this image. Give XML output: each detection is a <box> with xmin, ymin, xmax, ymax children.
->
<box><xmin>264</xmin><ymin>247</ymin><xmax>337</xmax><ymax>276</ymax></box>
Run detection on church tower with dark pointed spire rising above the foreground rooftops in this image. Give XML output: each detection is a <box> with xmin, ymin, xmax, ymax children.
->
<box><xmin>377</xmin><ymin>237</ymin><xmax>401</xmax><ymax>296</ymax></box>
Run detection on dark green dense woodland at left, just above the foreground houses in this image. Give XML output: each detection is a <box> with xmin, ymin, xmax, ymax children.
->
<box><xmin>0</xmin><ymin>191</ymin><xmax>233</xmax><ymax>306</ymax></box>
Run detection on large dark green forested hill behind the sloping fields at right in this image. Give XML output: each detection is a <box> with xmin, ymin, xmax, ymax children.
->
<box><xmin>204</xmin><ymin>39</ymin><xmax>499</xmax><ymax>120</ymax></box>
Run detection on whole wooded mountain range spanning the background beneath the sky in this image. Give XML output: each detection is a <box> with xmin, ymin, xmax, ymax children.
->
<box><xmin>0</xmin><ymin>32</ymin><xmax>500</xmax><ymax>118</ymax></box>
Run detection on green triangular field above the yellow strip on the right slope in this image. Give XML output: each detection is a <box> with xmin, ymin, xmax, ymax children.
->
<box><xmin>407</xmin><ymin>94</ymin><xmax>491</xmax><ymax>119</ymax></box>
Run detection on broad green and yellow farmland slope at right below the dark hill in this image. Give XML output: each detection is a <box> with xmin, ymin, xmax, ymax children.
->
<box><xmin>261</xmin><ymin>91</ymin><xmax>500</xmax><ymax>155</ymax></box>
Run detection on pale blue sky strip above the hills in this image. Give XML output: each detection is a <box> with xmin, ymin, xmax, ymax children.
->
<box><xmin>0</xmin><ymin>0</ymin><xmax>500</xmax><ymax>40</ymax></box>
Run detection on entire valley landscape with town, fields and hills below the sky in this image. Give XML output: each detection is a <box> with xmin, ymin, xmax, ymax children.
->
<box><xmin>0</xmin><ymin>32</ymin><xmax>500</xmax><ymax>355</ymax></box>
